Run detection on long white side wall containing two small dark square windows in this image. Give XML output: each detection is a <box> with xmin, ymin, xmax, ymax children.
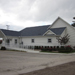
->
<box><xmin>22</xmin><ymin>36</ymin><xmax>58</xmax><ymax>46</ymax></box>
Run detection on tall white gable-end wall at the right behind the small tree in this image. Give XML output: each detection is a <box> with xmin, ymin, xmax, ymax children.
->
<box><xmin>51</xmin><ymin>19</ymin><xmax>75</xmax><ymax>46</ymax></box>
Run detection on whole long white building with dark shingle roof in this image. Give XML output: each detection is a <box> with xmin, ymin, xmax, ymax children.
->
<box><xmin>0</xmin><ymin>17</ymin><xmax>75</xmax><ymax>49</ymax></box>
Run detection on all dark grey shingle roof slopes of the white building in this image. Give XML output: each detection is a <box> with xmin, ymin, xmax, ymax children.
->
<box><xmin>0</xmin><ymin>25</ymin><xmax>66</xmax><ymax>36</ymax></box>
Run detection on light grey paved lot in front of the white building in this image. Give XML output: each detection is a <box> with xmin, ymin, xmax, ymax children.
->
<box><xmin>0</xmin><ymin>51</ymin><xmax>75</xmax><ymax>75</ymax></box>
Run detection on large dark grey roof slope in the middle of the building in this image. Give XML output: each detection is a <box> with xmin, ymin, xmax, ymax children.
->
<box><xmin>20</xmin><ymin>25</ymin><xmax>50</xmax><ymax>36</ymax></box>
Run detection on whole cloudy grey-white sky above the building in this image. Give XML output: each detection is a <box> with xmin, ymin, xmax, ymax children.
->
<box><xmin>0</xmin><ymin>0</ymin><xmax>75</xmax><ymax>31</ymax></box>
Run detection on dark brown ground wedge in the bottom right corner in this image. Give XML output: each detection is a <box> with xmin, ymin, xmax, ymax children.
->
<box><xmin>19</xmin><ymin>62</ymin><xmax>75</xmax><ymax>75</ymax></box>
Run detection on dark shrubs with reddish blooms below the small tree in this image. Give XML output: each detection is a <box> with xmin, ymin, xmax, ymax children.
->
<box><xmin>41</xmin><ymin>45</ymin><xmax>75</xmax><ymax>53</ymax></box>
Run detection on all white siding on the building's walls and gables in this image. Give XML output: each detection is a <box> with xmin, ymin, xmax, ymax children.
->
<box><xmin>0</xmin><ymin>18</ymin><xmax>75</xmax><ymax>47</ymax></box>
